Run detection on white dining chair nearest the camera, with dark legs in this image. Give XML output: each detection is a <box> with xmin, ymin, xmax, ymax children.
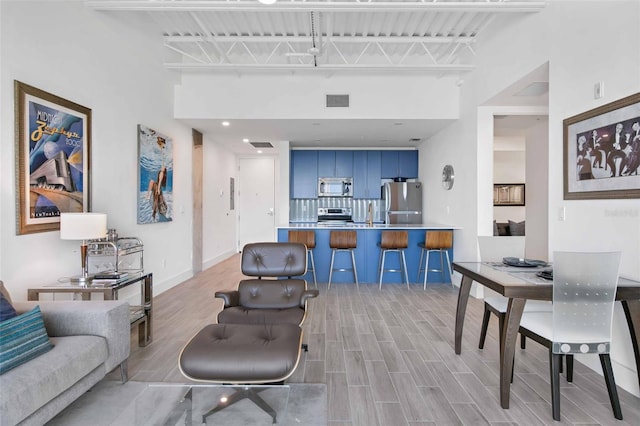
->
<box><xmin>520</xmin><ymin>252</ymin><xmax>622</xmax><ymax>420</ymax></box>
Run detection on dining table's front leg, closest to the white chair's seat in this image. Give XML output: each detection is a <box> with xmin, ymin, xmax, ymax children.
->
<box><xmin>500</xmin><ymin>299</ymin><xmax>527</xmax><ymax>408</ymax></box>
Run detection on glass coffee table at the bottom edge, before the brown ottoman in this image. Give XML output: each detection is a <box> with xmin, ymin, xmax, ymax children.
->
<box><xmin>122</xmin><ymin>383</ymin><xmax>290</xmax><ymax>426</ymax></box>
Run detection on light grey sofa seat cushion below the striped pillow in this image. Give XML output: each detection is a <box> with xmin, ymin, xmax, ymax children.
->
<box><xmin>0</xmin><ymin>336</ymin><xmax>108</xmax><ymax>424</ymax></box>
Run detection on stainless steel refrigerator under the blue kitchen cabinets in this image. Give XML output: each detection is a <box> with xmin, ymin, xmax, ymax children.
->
<box><xmin>382</xmin><ymin>182</ymin><xmax>422</xmax><ymax>224</ymax></box>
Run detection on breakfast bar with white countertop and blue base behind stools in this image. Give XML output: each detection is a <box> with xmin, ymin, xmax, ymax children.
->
<box><xmin>277</xmin><ymin>222</ymin><xmax>460</xmax><ymax>284</ymax></box>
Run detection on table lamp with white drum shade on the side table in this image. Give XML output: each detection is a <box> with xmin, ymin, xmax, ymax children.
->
<box><xmin>60</xmin><ymin>213</ymin><xmax>107</xmax><ymax>285</ymax></box>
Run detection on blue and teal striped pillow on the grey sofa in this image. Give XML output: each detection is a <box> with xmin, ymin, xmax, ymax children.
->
<box><xmin>0</xmin><ymin>306</ymin><xmax>53</xmax><ymax>374</ymax></box>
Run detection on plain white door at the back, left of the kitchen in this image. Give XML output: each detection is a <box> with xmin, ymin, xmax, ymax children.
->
<box><xmin>238</xmin><ymin>157</ymin><xmax>276</xmax><ymax>250</ymax></box>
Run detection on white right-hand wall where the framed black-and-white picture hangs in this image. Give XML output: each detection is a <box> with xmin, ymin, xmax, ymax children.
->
<box><xmin>421</xmin><ymin>0</ymin><xmax>640</xmax><ymax>395</ymax></box>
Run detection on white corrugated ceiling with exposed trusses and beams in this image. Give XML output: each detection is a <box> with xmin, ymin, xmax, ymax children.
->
<box><xmin>85</xmin><ymin>0</ymin><xmax>546</xmax><ymax>74</ymax></box>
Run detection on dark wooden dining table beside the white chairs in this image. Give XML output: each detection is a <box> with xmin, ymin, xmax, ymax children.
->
<box><xmin>453</xmin><ymin>262</ymin><xmax>640</xmax><ymax>408</ymax></box>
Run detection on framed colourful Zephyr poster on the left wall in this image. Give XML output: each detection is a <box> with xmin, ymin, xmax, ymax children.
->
<box><xmin>14</xmin><ymin>80</ymin><xmax>91</xmax><ymax>235</ymax></box>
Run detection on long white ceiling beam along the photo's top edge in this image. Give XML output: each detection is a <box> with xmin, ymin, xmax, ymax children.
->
<box><xmin>85</xmin><ymin>0</ymin><xmax>547</xmax><ymax>13</ymax></box>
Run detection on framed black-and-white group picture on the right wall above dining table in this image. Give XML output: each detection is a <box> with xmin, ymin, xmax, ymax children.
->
<box><xmin>563</xmin><ymin>93</ymin><xmax>640</xmax><ymax>200</ymax></box>
